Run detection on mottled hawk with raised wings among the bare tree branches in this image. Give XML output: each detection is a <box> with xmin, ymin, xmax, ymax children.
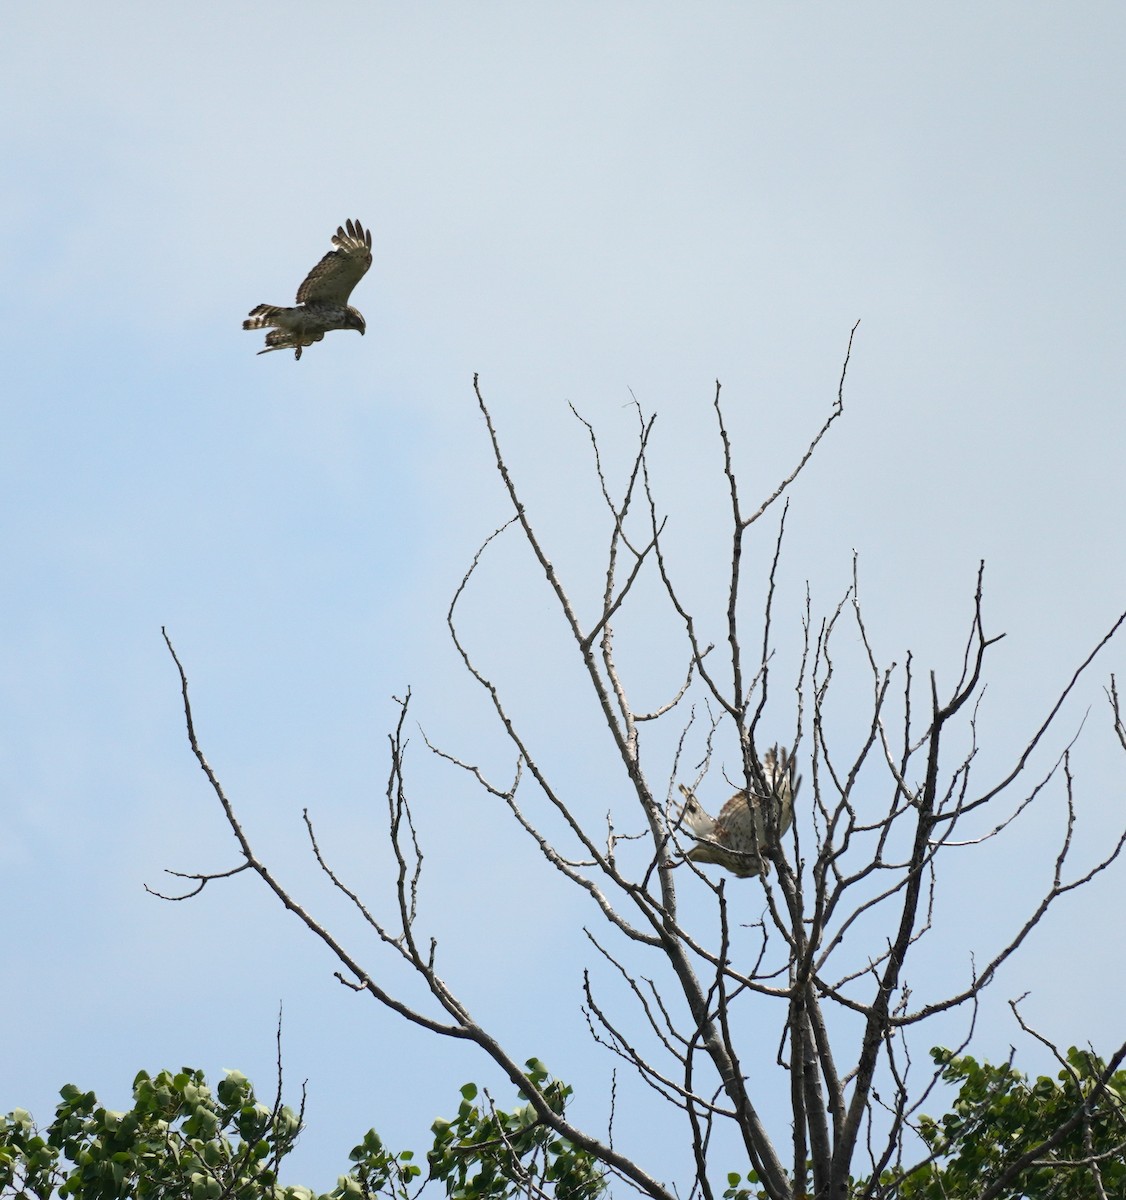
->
<box><xmin>677</xmin><ymin>746</ymin><xmax>801</xmax><ymax>880</ymax></box>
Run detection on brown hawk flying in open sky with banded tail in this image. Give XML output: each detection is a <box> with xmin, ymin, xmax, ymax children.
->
<box><xmin>242</xmin><ymin>221</ymin><xmax>371</xmax><ymax>359</ymax></box>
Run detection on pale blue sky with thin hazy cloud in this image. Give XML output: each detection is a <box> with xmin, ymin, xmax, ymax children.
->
<box><xmin>0</xmin><ymin>0</ymin><xmax>1126</xmax><ymax>1188</ymax></box>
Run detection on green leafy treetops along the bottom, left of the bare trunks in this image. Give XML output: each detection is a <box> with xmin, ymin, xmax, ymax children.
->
<box><xmin>0</xmin><ymin>1058</ymin><xmax>604</xmax><ymax>1200</ymax></box>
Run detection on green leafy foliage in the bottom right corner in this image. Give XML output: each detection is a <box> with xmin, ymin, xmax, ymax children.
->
<box><xmin>875</xmin><ymin>1046</ymin><xmax>1126</xmax><ymax>1200</ymax></box>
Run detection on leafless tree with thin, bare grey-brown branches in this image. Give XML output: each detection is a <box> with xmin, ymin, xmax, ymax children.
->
<box><xmin>153</xmin><ymin>328</ymin><xmax>1126</xmax><ymax>1200</ymax></box>
